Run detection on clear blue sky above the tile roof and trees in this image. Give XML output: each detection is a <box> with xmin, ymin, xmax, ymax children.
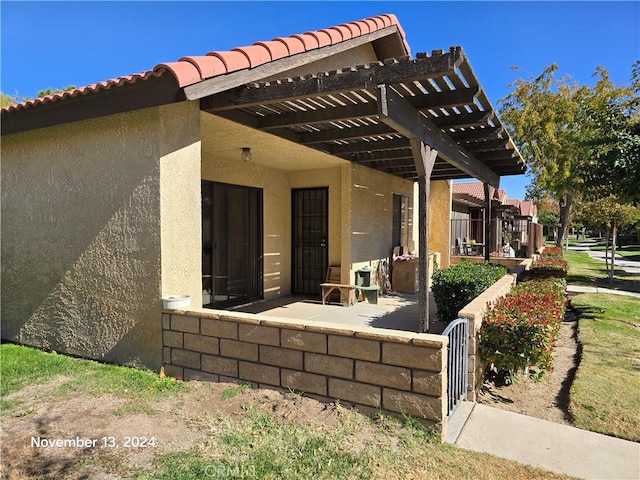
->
<box><xmin>0</xmin><ymin>0</ymin><xmax>640</xmax><ymax>198</ymax></box>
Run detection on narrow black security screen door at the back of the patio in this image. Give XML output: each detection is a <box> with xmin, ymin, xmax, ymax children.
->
<box><xmin>291</xmin><ymin>188</ymin><xmax>329</xmax><ymax>296</ymax></box>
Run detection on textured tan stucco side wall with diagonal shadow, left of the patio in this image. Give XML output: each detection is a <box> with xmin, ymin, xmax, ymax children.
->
<box><xmin>2</xmin><ymin>104</ymin><xmax>200</xmax><ymax>368</ymax></box>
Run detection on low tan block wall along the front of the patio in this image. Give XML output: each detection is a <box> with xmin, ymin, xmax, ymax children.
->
<box><xmin>162</xmin><ymin>309</ymin><xmax>448</xmax><ymax>435</ymax></box>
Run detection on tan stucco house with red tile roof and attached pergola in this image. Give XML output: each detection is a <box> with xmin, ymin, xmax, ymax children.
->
<box><xmin>1</xmin><ymin>15</ymin><xmax>524</xmax><ymax>368</ymax></box>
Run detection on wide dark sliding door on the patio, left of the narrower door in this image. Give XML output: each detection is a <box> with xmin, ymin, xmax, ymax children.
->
<box><xmin>202</xmin><ymin>181</ymin><xmax>263</xmax><ymax>308</ymax></box>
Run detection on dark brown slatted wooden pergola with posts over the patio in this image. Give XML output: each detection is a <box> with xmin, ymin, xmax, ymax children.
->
<box><xmin>200</xmin><ymin>47</ymin><xmax>525</xmax><ymax>331</ymax></box>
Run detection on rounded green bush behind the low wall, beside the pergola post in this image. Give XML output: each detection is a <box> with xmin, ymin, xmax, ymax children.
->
<box><xmin>431</xmin><ymin>260</ymin><xmax>507</xmax><ymax>323</ymax></box>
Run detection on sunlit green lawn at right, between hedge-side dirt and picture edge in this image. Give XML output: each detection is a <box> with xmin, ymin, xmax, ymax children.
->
<box><xmin>570</xmin><ymin>293</ymin><xmax>640</xmax><ymax>442</ymax></box>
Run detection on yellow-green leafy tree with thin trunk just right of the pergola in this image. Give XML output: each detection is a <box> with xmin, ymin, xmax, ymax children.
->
<box><xmin>500</xmin><ymin>64</ymin><xmax>590</xmax><ymax>246</ymax></box>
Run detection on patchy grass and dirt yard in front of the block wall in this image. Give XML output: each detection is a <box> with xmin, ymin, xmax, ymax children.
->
<box><xmin>0</xmin><ymin>344</ymin><xmax>568</xmax><ymax>480</ymax></box>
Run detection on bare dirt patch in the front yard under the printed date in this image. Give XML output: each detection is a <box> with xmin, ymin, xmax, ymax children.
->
<box><xmin>0</xmin><ymin>379</ymin><xmax>348</xmax><ymax>480</ymax></box>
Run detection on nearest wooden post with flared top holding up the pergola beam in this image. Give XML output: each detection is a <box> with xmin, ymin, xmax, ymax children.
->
<box><xmin>411</xmin><ymin>138</ymin><xmax>438</xmax><ymax>333</ymax></box>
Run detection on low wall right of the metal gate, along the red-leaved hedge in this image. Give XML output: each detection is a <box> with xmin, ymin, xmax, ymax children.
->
<box><xmin>458</xmin><ymin>274</ymin><xmax>517</xmax><ymax>402</ymax></box>
